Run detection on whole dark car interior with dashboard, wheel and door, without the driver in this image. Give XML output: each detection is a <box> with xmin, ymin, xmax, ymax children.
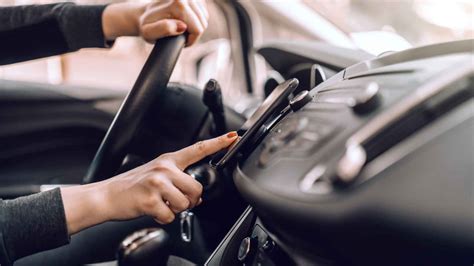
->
<box><xmin>0</xmin><ymin>1</ymin><xmax>474</xmax><ymax>265</ymax></box>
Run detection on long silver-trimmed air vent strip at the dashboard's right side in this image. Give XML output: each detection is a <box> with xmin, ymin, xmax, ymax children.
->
<box><xmin>334</xmin><ymin>63</ymin><xmax>474</xmax><ymax>185</ymax></box>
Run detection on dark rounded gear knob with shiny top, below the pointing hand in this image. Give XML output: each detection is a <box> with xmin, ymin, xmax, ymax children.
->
<box><xmin>117</xmin><ymin>228</ymin><xmax>170</xmax><ymax>266</ymax></box>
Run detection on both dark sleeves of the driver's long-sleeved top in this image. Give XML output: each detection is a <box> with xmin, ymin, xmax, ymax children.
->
<box><xmin>0</xmin><ymin>3</ymin><xmax>110</xmax><ymax>265</ymax></box>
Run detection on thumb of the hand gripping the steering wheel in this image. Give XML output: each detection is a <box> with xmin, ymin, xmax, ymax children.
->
<box><xmin>141</xmin><ymin>19</ymin><xmax>187</xmax><ymax>42</ymax></box>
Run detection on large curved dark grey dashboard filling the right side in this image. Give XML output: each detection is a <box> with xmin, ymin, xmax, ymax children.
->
<box><xmin>206</xmin><ymin>40</ymin><xmax>474</xmax><ymax>265</ymax></box>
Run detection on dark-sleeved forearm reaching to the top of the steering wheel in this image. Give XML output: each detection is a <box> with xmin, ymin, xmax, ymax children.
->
<box><xmin>0</xmin><ymin>3</ymin><xmax>106</xmax><ymax>65</ymax></box>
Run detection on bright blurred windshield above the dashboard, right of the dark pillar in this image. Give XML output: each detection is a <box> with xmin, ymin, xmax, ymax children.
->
<box><xmin>252</xmin><ymin>0</ymin><xmax>474</xmax><ymax>54</ymax></box>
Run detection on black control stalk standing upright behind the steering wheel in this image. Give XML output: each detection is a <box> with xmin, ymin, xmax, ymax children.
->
<box><xmin>202</xmin><ymin>79</ymin><xmax>227</xmax><ymax>136</ymax></box>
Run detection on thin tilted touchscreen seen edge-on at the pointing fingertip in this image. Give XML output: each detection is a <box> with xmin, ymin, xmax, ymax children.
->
<box><xmin>210</xmin><ymin>79</ymin><xmax>298</xmax><ymax>168</ymax></box>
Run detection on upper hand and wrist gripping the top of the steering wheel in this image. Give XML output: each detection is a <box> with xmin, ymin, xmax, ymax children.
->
<box><xmin>102</xmin><ymin>0</ymin><xmax>209</xmax><ymax>46</ymax></box>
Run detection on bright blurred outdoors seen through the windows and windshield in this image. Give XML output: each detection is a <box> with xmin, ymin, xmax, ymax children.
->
<box><xmin>0</xmin><ymin>0</ymin><xmax>474</xmax><ymax>109</ymax></box>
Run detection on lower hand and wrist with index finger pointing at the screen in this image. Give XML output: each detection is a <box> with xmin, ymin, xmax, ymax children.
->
<box><xmin>61</xmin><ymin>132</ymin><xmax>237</xmax><ymax>234</ymax></box>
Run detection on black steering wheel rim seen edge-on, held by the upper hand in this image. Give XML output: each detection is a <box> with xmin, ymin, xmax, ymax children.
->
<box><xmin>83</xmin><ymin>35</ymin><xmax>186</xmax><ymax>184</ymax></box>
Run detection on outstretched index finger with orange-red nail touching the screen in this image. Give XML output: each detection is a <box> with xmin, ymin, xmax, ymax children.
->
<box><xmin>172</xmin><ymin>131</ymin><xmax>238</xmax><ymax>170</ymax></box>
